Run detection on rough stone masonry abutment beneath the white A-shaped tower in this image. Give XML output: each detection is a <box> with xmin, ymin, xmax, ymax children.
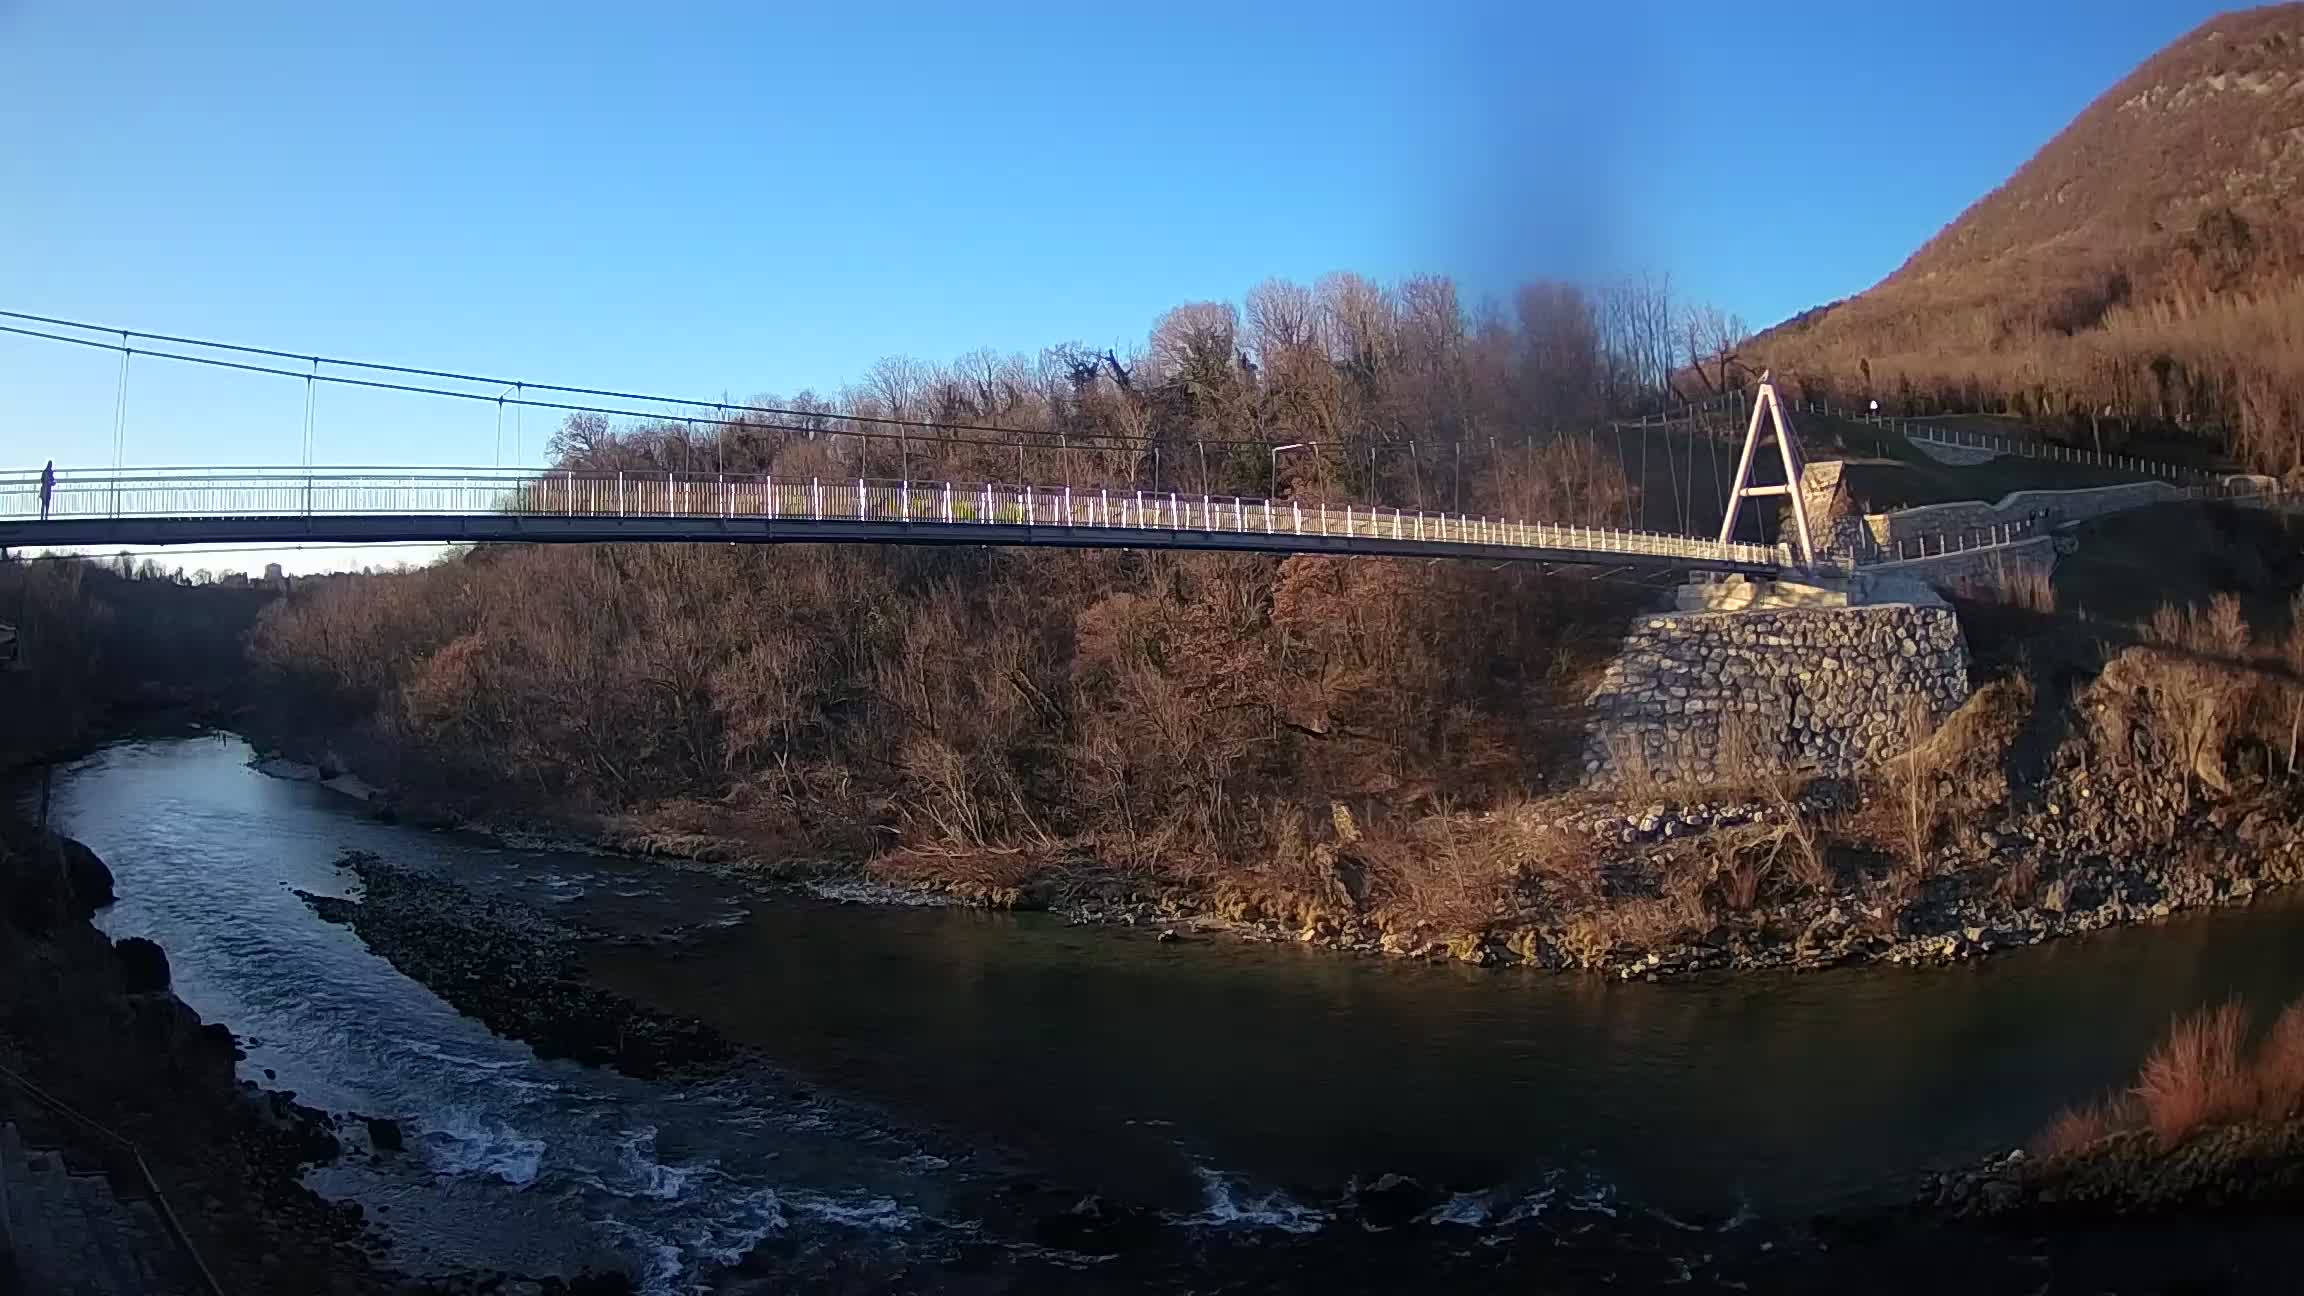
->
<box><xmin>1585</xmin><ymin>602</ymin><xmax>1968</xmax><ymax>784</ymax></box>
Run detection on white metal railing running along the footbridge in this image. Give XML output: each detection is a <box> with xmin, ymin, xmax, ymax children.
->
<box><xmin>0</xmin><ymin>468</ymin><xmax>1790</xmax><ymax>567</ymax></box>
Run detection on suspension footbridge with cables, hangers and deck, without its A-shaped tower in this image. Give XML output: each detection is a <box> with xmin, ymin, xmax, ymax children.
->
<box><xmin>0</xmin><ymin>311</ymin><xmax>1813</xmax><ymax>579</ymax></box>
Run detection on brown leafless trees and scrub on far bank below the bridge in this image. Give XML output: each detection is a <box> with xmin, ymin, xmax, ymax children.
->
<box><xmin>229</xmin><ymin>493</ymin><xmax>2304</xmax><ymax>973</ymax></box>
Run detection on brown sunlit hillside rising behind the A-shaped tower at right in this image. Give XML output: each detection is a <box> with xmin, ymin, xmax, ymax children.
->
<box><xmin>1751</xmin><ymin>5</ymin><xmax>2304</xmax><ymax>470</ymax></box>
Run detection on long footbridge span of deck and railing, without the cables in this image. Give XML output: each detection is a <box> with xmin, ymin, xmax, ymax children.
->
<box><xmin>0</xmin><ymin>470</ymin><xmax>1788</xmax><ymax>572</ymax></box>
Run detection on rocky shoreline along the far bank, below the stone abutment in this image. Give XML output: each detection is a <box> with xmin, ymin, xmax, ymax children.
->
<box><xmin>256</xmin><ymin>733</ymin><xmax>2304</xmax><ymax>980</ymax></box>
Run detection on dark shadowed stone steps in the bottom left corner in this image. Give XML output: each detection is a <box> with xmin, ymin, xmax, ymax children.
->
<box><xmin>0</xmin><ymin>1123</ymin><xmax>200</xmax><ymax>1296</ymax></box>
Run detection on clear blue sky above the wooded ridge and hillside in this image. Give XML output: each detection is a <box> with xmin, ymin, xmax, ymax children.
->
<box><xmin>0</xmin><ymin>0</ymin><xmax>2219</xmax><ymax>564</ymax></box>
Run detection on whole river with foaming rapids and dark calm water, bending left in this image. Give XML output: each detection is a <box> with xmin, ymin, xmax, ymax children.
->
<box><xmin>36</xmin><ymin>736</ymin><xmax>2304</xmax><ymax>1291</ymax></box>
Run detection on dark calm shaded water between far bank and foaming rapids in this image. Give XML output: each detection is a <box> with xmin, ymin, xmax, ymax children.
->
<box><xmin>594</xmin><ymin>830</ymin><xmax>2304</xmax><ymax>1213</ymax></box>
